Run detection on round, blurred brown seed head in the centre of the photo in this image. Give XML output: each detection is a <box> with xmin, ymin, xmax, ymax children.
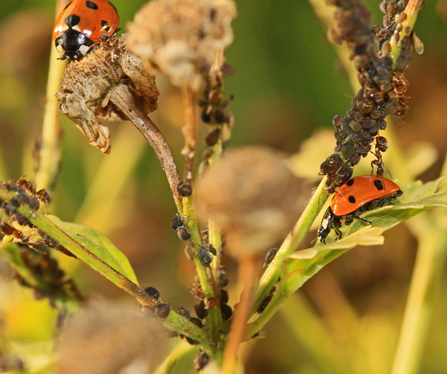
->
<box><xmin>197</xmin><ymin>147</ymin><xmax>304</xmax><ymax>257</ymax></box>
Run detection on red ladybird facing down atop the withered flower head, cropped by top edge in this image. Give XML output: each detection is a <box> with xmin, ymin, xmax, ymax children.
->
<box><xmin>53</xmin><ymin>0</ymin><xmax>120</xmax><ymax>60</ymax></box>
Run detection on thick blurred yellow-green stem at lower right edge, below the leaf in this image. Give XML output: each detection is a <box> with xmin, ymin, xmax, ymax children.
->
<box><xmin>391</xmin><ymin>216</ymin><xmax>447</xmax><ymax>374</ymax></box>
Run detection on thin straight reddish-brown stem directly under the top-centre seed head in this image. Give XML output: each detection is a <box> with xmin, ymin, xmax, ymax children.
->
<box><xmin>182</xmin><ymin>87</ymin><xmax>198</xmax><ymax>186</ymax></box>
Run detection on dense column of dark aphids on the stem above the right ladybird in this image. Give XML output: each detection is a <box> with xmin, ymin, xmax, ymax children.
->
<box><xmin>321</xmin><ymin>0</ymin><xmax>411</xmax><ymax>193</ymax></box>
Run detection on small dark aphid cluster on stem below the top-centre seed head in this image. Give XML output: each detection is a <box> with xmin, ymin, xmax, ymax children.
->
<box><xmin>198</xmin><ymin>63</ymin><xmax>234</xmax><ymax>164</ymax></box>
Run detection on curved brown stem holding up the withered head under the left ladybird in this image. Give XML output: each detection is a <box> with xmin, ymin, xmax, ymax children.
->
<box><xmin>110</xmin><ymin>84</ymin><xmax>183</xmax><ymax>213</ymax></box>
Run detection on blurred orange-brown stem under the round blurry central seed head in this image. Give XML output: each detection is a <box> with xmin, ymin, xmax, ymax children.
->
<box><xmin>222</xmin><ymin>256</ymin><xmax>258</xmax><ymax>374</ymax></box>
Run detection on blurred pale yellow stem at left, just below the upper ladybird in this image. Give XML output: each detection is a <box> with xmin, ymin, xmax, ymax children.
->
<box><xmin>36</xmin><ymin>42</ymin><xmax>67</xmax><ymax>189</ymax></box>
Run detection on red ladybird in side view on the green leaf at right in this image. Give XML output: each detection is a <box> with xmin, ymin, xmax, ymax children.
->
<box><xmin>318</xmin><ymin>175</ymin><xmax>403</xmax><ymax>244</ymax></box>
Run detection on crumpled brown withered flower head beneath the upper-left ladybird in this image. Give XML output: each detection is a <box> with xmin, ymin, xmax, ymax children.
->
<box><xmin>56</xmin><ymin>35</ymin><xmax>159</xmax><ymax>154</ymax></box>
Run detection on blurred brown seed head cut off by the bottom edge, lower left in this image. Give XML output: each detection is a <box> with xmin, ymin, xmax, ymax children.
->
<box><xmin>56</xmin><ymin>304</ymin><xmax>168</xmax><ymax>374</ymax></box>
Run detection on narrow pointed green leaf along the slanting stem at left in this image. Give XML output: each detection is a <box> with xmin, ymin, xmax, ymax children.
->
<box><xmin>46</xmin><ymin>215</ymin><xmax>138</xmax><ymax>284</ymax></box>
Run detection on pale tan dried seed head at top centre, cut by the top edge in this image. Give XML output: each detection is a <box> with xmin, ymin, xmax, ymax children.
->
<box><xmin>128</xmin><ymin>0</ymin><xmax>236</xmax><ymax>91</ymax></box>
